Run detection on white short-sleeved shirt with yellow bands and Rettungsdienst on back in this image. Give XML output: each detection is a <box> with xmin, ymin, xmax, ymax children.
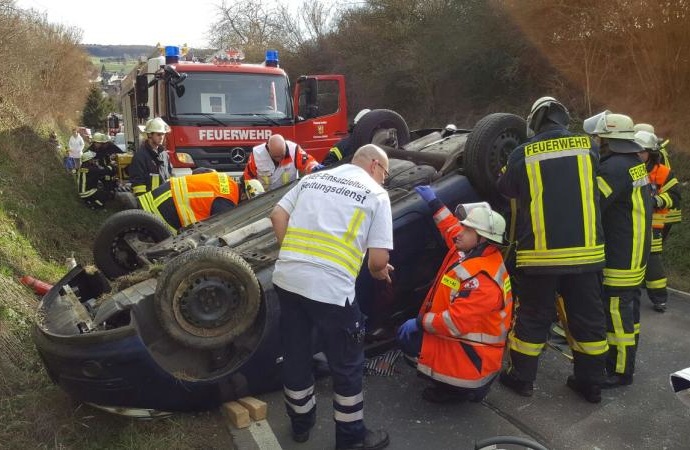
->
<box><xmin>273</xmin><ymin>164</ymin><xmax>393</xmax><ymax>306</ymax></box>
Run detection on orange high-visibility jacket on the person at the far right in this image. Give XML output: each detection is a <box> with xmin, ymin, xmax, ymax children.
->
<box><xmin>647</xmin><ymin>163</ymin><xmax>681</xmax><ymax>252</ymax></box>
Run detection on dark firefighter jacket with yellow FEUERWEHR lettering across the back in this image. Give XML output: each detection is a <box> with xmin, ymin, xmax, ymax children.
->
<box><xmin>498</xmin><ymin>126</ymin><xmax>605</xmax><ymax>273</ymax></box>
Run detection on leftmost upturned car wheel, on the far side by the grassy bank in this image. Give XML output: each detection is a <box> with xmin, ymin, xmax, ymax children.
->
<box><xmin>93</xmin><ymin>209</ymin><xmax>173</xmax><ymax>280</ymax></box>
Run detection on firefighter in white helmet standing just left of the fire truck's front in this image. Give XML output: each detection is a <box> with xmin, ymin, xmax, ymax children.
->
<box><xmin>128</xmin><ymin>117</ymin><xmax>172</xmax><ymax>196</ymax></box>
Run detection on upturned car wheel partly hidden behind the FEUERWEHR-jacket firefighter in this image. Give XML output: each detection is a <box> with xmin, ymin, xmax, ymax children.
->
<box><xmin>463</xmin><ymin>113</ymin><xmax>527</xmax><ymax>197</ymax></box>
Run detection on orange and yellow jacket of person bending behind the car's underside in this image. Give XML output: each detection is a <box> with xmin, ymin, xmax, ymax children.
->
<box><xmin>170</xmin><ymin>172</ymin><xmax>240</xmax><ymax>227</ymax></box>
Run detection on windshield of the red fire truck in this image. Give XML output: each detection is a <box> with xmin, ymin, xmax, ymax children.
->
<box><xmin>170</xmin><ymin>72</ymin><xmax>292</xmax><ymax>123</ymax></box>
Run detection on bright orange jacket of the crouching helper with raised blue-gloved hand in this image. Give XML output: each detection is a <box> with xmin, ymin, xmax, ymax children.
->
<box><xmin>417</xmin><ymin>206</ymin><xmax>512</xmax><ymax>388</ymax></box>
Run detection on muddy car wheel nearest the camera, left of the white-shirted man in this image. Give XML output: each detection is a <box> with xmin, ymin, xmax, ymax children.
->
<box><xmin>155</xmin><ymin>247</ymin><xmax>261</xmax><ymax>349</ymax></box>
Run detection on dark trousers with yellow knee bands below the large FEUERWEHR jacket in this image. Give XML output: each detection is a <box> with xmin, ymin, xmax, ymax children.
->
<box><xmin>509</xmin><ymin>272</ymin><xmax>607</xmax><ymax>384</ymax></box>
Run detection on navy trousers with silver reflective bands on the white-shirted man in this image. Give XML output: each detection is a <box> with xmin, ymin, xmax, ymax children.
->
<box><xmin>275</xmin><ymin>286</ymin><xmax>365</xmax><ymax>447</ymax></box>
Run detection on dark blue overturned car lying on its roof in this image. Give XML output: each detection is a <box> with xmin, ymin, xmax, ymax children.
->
<box><xmin>34</xmin><ymin>110</ymin><xmax>525</xmax><ymax>415</ymax></box>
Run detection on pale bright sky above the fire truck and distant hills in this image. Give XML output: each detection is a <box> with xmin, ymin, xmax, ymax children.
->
<box><xmin>15</xmin><ymin>0</ymin><xmax>221</xmax><ymax>48</ymax></box>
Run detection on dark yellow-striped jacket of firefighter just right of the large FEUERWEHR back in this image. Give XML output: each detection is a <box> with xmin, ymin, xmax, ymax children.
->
<box><xmin>597</xmin><ymin>153</ymin><xmax>652</xmax><ymax>289</ymax></box>
